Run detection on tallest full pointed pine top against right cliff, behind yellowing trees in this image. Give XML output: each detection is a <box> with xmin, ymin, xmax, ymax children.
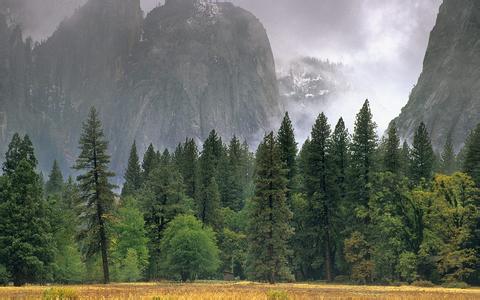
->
<box><xmin>410</xmin><ymin>122</ymin><xmax>435</xmax><ymax>183</ymax></box>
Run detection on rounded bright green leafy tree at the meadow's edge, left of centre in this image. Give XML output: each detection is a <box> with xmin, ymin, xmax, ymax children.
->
<box><xmin>160</xmin><ymin>215</ymin><xmax>220</xmax><ymax>281</ymax></box>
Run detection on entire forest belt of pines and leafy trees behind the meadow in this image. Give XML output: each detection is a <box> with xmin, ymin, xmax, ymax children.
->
<box><xmin>0</xmin><ymin>100</ymin><xmax>480</xmax><ymax>287</ymax></box>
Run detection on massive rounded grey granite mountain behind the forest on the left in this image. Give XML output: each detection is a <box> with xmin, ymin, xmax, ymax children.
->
<box><xmin>0</xmin><ymin>0</ymin><xmax>282</xmax><ymax>174</ymax></box>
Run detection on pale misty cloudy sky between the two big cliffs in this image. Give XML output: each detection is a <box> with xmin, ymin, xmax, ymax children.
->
<box><xmin>142</xmin><ymin>0</ymin><xmax>442</xmax><ymax>132</ymax></box>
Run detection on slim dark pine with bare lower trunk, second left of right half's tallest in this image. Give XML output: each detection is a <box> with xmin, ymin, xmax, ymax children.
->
<box><xmin>305</xmin><ymin>113</ymin><xmax>337</xmax><ymax>281</ymax></box>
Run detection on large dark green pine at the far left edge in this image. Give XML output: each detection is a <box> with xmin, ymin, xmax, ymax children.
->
<box><xmin>0</xmin><ymin>134</ymin><xmax>54</xmax><ymax>286</ymax></box>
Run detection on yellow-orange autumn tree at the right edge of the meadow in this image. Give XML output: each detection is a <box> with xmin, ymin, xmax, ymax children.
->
<box><xmin>418</xmin><ymin>173</ymin><xmax>480</xmax><ymax>282</ymax></box>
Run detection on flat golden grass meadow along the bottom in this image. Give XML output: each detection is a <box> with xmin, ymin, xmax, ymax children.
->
<box><xmin>0</xmin><ymin>282</ymin><xmax>480</xmax><ymax>300</ymax></box>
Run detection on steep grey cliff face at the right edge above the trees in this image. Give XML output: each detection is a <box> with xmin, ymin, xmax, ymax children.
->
<box><xmin>395</xmin><ymin>0</ymin><xmax>480</xmax><ymax>151</ymax></box>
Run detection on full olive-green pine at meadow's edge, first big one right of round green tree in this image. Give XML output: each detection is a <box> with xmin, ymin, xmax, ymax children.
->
<box><xmin>248</xmin><ymin>132</ymin><xmax>293</xmax><ymax>284</ymax></box>
